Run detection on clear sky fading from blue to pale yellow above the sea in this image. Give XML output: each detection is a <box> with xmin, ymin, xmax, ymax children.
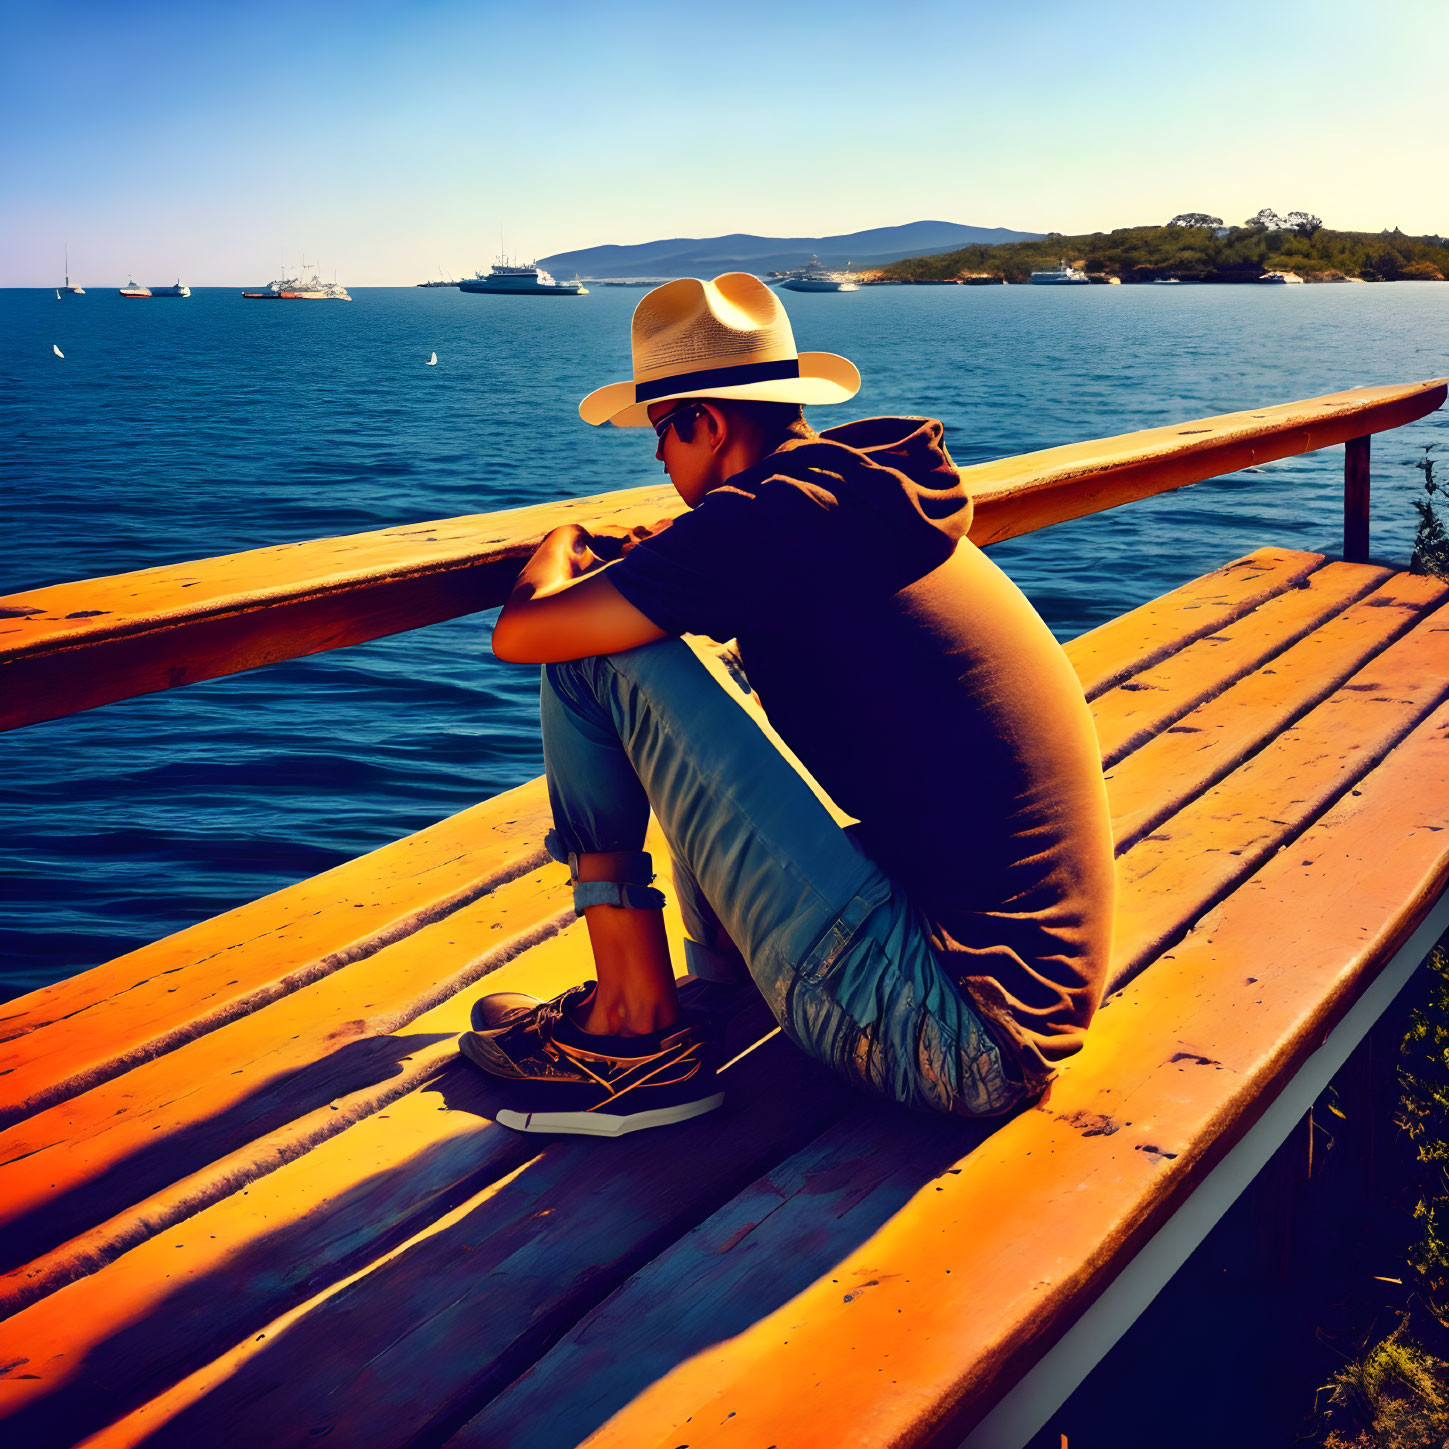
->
<box><xmin>0</xmin><ymin>0</ymin><xmax>1449</xmax><ymax>287</ymax></box>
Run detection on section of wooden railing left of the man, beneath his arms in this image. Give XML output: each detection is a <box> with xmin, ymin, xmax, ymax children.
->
<box><xmin>0</xmin><ymin>487</ymin><xmax>682</xmax><ymax>729</ymax></box>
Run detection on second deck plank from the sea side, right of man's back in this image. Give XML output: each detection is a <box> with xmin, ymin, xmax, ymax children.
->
<box><xmin>1093</xmin><ymin>564</ymin><xmax>1392</xmax><ymax>767</ymax></box>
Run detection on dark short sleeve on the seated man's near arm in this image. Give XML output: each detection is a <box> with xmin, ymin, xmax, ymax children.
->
<box><xmin>607</xmin><ymin>478</ymin><xmax>835</xmax><ymax>640</ymax></box>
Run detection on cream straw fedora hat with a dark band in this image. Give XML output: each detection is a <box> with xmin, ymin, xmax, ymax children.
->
<box><xmin>578</xmin><ymin>272</ymin><xmax>861</xmax><ymax>427</ymax></box>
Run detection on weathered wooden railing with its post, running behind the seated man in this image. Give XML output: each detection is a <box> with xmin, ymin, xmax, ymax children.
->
<box><xmin>0</xmin><ymin>378</ymin><xmax>1446</xmax><ymax>729</ymax></box>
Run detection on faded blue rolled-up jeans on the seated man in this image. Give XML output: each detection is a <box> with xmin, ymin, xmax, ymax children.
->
<box><xmin>540</xmin><ymin>639</ymin><xmax>1026</xmax><ymax>1117</ymax></box>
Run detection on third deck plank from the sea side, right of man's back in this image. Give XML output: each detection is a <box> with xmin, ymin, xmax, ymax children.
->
<box><xmin>1107</xmin><ymin>574</ymin><xmax>1449</xmax><ymax>851</ymax></box>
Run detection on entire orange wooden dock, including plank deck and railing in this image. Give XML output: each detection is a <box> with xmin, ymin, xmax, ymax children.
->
<box><xmin>0</xmin><ymin>381</ymin><xmax>1449</xmax><ymax>1449</ymax></box>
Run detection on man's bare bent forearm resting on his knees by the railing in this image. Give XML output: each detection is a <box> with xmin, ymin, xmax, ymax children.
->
<box><xmin>493</xmin><ymin>523</ymin><xmax>665</xmax><ymax>664</ymax></box>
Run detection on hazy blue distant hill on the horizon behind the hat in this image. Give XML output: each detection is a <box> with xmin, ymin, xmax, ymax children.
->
<box><xmin>539</xmin><ymin>222</ymin><xmax>1042</xmax><ymax>277</ymax></box>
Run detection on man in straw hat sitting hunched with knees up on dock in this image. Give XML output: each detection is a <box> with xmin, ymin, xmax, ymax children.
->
<box><xmin>459</xmin><ymin>272</ymin><xmax>1113</xmax><ymax>1135</ymax></box>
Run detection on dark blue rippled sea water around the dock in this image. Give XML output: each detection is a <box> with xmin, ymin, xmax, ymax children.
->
<box><xmin>8</xmin><ymin>283</ymin><xmax>1449</xmax><ymax>997</ymax></box>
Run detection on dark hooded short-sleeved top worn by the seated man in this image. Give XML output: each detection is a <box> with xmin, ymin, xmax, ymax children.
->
<box><xmin>609</xmin><ymin>417</ymin><xmax>1113</xmax><ymax>1084</ymax></box>
